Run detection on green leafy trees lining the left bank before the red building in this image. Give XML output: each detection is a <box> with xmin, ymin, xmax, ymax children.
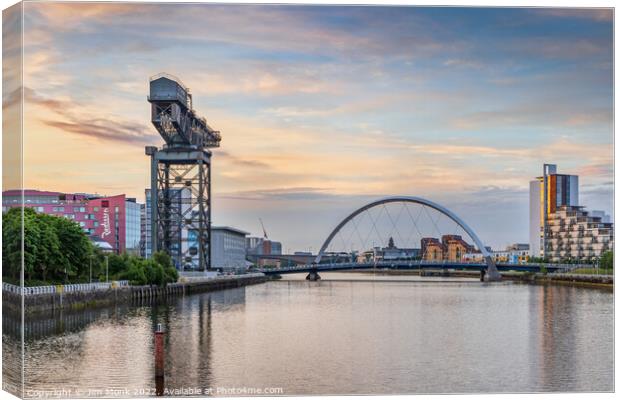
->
<box><xmin>2</xmin><ymin>208</ymin><xmax>179</xmax><ymax>286</ymax></box>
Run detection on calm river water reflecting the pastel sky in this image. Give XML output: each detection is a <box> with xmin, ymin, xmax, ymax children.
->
<box><xmin>2</xmin><ymin>273</ymin><xmax>613</xmax><ymax>397</ymax></box>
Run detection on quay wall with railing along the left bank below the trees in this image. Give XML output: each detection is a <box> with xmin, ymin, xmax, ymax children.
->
<box><xmin>2</xmin><ymin>274</ymin><xmax>269</xmax><ymax>314</ymax></box>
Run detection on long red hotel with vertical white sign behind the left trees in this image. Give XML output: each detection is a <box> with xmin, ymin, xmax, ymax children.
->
<box><xmin>2</xmin><ymin>189</ymin><xmax>140</xmax><ymax>253</ymax></box>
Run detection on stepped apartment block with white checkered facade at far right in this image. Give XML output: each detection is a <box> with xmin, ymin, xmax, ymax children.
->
<box><xmin>545</xmin><ymin>206</ymin><xmax>614</xmax><ymax>262</ymax></box>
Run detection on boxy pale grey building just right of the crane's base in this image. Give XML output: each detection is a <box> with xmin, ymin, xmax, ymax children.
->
<box><xmin>211</xmin><ymin>226</ymin><xmax>249</xmax><ymax>272</ymax></box>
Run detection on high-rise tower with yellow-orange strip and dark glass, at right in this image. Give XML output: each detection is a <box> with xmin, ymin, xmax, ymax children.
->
<box><xmin>529</xmin><ymin>164</ymin><xmax>579</xmax><ymax>257</ymax></box>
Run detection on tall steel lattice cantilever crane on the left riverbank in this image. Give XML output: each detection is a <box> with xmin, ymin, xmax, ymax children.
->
<box><xmin>145</xmin><ymin>73</ymin><xmax>221</xmax><ymax>271</ymax></box>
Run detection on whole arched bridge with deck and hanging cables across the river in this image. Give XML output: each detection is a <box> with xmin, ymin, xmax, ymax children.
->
<box><xmin>259</xmin><ymin>196</ymin><xmax>504</xmax><ymax>281</ymax></box>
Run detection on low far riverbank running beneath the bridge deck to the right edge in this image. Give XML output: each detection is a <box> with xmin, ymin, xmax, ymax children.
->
<box><xmin>341</xmin><ymin>269</ymin><xmax>614</xmax><ymax>290</ymax></box>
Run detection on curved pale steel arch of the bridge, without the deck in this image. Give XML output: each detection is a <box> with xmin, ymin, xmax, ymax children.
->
<box><xmin>314</xmin><ymin>196</ymin><xmax>501</xmax><ymax>280</ymax></box>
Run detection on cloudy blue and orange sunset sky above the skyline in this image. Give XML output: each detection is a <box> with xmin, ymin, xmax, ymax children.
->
<box><xmin>3</xmin><ymin>2</ymin><xmax>613</xmax><ymax>251</ymax></box>
